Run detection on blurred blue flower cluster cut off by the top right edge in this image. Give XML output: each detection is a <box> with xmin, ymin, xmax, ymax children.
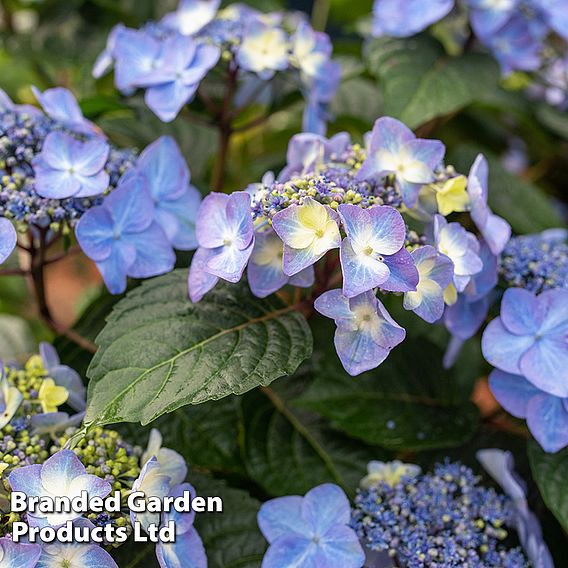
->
<box><xmin>373</xmin><ymin>0</ymin><xmax>568</xmax><ymax>73</ymax></box>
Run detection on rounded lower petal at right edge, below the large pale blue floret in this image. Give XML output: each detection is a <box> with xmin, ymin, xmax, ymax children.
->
<box><xmin>527</xmin><ymin>394</ymin><xmax>568</xmax><ymax>453</ymax></box>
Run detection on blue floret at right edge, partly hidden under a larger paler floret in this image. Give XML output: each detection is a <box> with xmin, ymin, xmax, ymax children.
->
<box><xmin>489</xmin><ymin>369</ymin><xmax>568</xmax><ymax>452</ymax></box>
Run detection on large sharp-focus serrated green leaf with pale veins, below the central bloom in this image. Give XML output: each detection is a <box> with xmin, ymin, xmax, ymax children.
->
<box><xmin>85</xmin><ymin>270</ymin><xmax>312</xmax><ymax>425</ymax></box>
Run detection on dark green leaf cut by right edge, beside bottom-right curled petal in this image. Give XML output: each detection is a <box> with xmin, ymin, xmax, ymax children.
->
<box><xmin>528</xmin><ymin>440</ymin><xmax>568</xmax><ymax>531</ymax></box>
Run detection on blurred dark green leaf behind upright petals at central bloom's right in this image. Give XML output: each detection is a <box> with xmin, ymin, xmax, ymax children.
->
<box><xmin>448</xmin><ymin>144</ymin><xmax>564</xmax><ymax>234</ymax></box>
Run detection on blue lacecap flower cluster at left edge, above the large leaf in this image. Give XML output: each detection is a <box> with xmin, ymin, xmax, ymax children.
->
<box><xmin>0</xmin><ymin>89</ymin><xmax>201</xmax><ymax>293</ymax></box>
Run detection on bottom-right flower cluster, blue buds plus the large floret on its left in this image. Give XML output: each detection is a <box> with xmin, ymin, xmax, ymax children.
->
<box><xmin>258</xmin><ymin>449</ymin><xmax>553</xmax><ymax>568</ymax></box>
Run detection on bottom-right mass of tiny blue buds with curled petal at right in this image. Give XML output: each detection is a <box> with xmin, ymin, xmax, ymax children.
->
<box><xmin>351</xmin><ymin>458</ymin><xmax>552</xmax><ymax>568</ymax></box>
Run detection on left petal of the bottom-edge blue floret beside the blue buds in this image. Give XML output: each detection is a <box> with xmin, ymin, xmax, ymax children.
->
<box><xmin>257</xmin><ymin>495</ymin><xmax>311</xmax><ymax>543</ymax></box>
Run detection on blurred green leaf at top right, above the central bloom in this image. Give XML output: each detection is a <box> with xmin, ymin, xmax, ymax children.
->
<box><xmin>367</xmin><ymin>36</ymin><xmax>499</xmax><ymax>128</ymax></box>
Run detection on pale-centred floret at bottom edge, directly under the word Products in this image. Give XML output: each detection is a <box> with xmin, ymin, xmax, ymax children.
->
<box><xmin>35</xmin><ymin>541</ymin><xmax>118</xmax><ymax>568</ymax></box>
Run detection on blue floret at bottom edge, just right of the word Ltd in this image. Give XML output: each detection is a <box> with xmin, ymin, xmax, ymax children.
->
<box><xmin>156</xmin><ymin>483</ymin><xmax>207</xmax><ymax>568</ymax></box>
